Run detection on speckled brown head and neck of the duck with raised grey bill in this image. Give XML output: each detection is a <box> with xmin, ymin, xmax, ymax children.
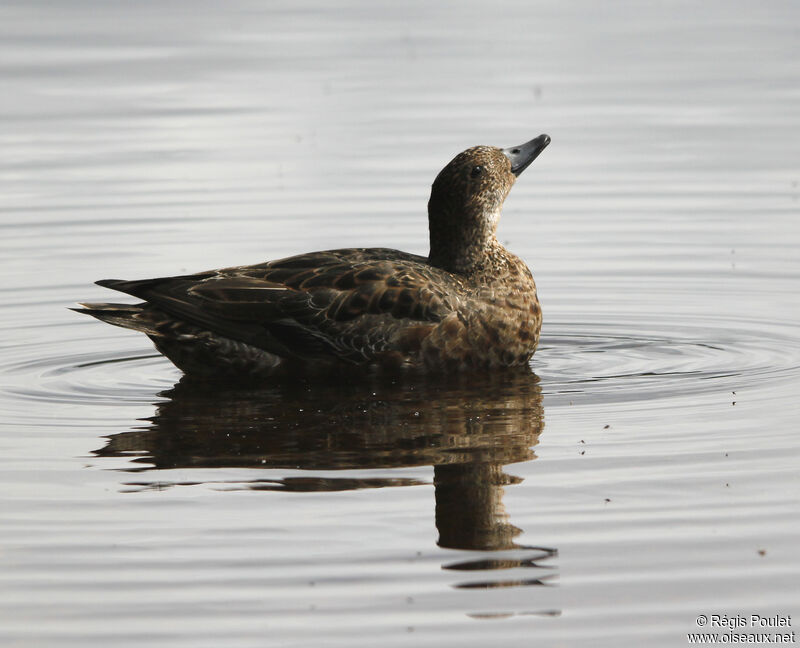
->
<box><xmin>428</xmin><ymin>135</ymin><xmax>550</xmax><ymax>274</ymax></box>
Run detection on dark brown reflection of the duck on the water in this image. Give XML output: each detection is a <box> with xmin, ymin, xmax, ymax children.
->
<box><xmin>95</xmin><ymin>371</ymin><xmax>549</xmax><ymax>569</ymax></box>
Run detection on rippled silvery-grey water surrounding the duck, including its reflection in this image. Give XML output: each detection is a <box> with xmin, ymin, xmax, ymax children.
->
<box><xmin>0</xmin><ymin>0</ymin><xmax>800</xmax><ymax>648</ymax></box>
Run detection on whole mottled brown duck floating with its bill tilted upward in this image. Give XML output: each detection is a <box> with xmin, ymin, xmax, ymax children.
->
<box><xmin>75</xmin><ymin>135</ymin><xmax>550</xmax><ymax>377</ymax></box>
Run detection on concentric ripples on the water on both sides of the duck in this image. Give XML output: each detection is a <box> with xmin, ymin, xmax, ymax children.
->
<box><xmin>0</xmin><ymin>314</ymin><xmax>800</xmax><ymax>412</ymax></box>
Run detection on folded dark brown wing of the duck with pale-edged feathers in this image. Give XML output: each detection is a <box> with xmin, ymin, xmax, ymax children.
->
<box><xmin>97</xmin><ymin>248</ymin><xmax>463</xmax><ymax>362</ymax></box>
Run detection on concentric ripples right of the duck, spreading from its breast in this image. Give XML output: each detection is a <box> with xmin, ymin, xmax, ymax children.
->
<box><xmin>534</xmin><ymin>316</ymin><xmax>800</xmax><ymax>402</ymax></box>
